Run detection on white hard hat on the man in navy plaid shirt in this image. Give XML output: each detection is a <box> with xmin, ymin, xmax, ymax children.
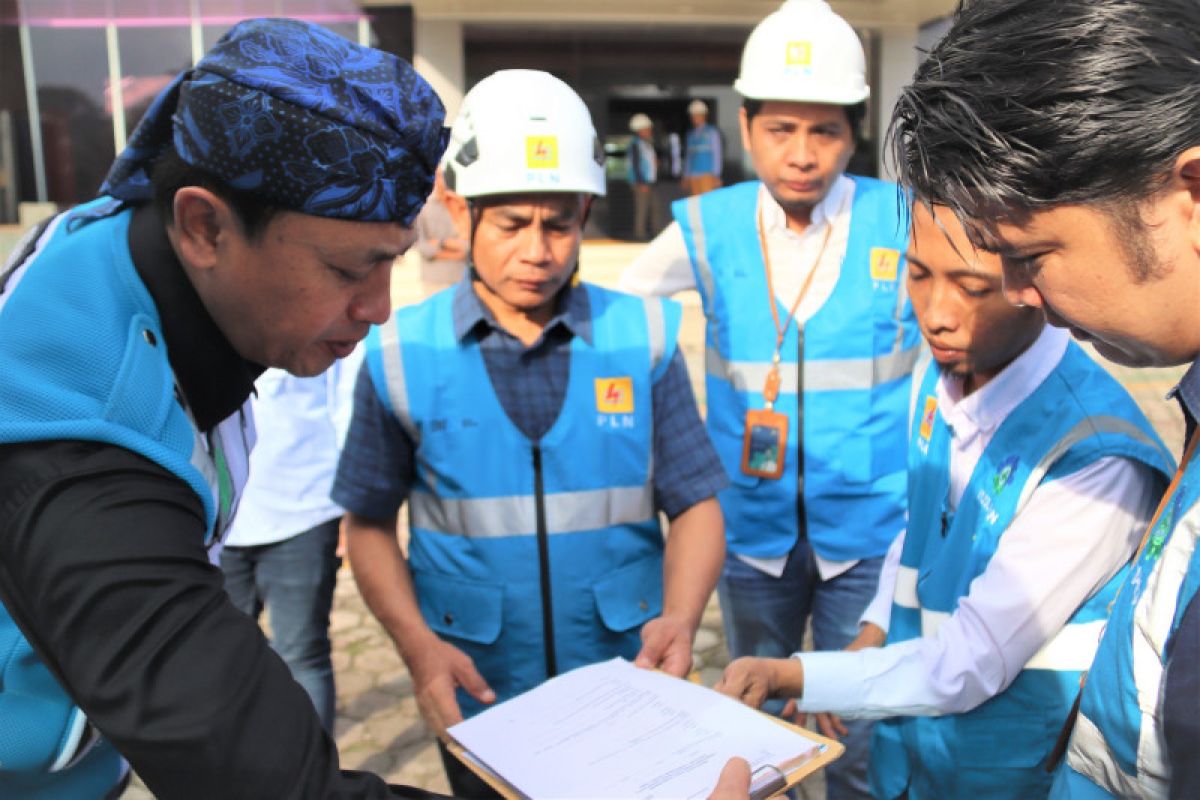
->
<box><xmin>442</xmin><ymin>70</ymin><xmax>605</xmax><ymax>198</ymax></box>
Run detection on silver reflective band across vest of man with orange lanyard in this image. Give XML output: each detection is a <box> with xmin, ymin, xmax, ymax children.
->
<box><xmin>704</xmin><ymin>347</ymin><xmax>920</xmax><ymax>395</ymax></box>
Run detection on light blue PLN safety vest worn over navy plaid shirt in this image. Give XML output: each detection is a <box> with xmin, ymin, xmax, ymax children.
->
<box><xmin>366</xmin><ymin>284</ymin><xmax>680</xmax><ymax>715</ymax></box>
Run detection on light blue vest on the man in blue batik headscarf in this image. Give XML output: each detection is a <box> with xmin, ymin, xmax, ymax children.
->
<box><xmin>0</xmin><ymin>199</ymin><xmax>243</xmax><ymax>800</ymax></box>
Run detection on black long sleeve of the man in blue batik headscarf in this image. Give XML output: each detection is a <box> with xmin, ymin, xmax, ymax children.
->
<box><xmin>0</xmin><ymin>441</ymin><xmax>448</xmax><ymax>799</ymax></box>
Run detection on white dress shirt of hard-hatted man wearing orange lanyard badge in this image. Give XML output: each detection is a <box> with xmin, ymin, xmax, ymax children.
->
<box><xmin>618</xmin><ymin>175</ymin><xmax>858</xmax><ymax>581</ymax></box>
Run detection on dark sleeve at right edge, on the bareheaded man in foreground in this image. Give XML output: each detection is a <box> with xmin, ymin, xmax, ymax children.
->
<box><xmin>1163</xmin><ymin>587</ymin><xmax>1200</xmax><ymax>800</ymax></box>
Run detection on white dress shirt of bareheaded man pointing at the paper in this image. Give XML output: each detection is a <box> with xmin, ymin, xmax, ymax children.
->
<box><xmin>793</xmin><ymin>326</ymin><xmax>1162</xmax><ymax>718</ymax></box>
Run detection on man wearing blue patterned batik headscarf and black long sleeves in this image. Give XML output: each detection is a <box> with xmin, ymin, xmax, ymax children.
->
<box><xmin>0</xmin><ymin>19</ymin><xmax>446</xmax><ymax>799</ymax></box>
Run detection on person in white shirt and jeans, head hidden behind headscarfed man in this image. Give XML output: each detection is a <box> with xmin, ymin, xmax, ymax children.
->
<box><xmin>221</xmin><ymin>347</ymin><xmax>362</xmax><ymax>734</ymax></box>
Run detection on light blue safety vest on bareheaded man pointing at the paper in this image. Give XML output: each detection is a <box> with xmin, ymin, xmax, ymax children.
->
<box><xmin>871</xmin><ymin>342</ymin><xmax>1172</xmax><ymax>800</ymax></box>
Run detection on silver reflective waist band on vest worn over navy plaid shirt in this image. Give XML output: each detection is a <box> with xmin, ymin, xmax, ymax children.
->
<box><xmin>409</xmin><ymin>486</ymin><xmax>654</xmax><ymax>539</ymax></box>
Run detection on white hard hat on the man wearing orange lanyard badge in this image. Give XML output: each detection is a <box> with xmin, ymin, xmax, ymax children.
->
<box><xmin>733</xmin><ymin>0</ymin><xmax>870</xmax><ymax>106</ymax></box>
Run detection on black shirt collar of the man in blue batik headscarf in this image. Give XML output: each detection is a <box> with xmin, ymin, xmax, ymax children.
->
<box><xmin>128</xmin><ymin>203</ymin><xmax>263</xmax><ymax>431</ymax></box>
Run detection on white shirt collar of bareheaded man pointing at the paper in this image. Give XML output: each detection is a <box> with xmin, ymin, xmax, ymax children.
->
<box><xmin>937</xmin><ymin>325</ymin><xmax>1070</xmax><ymax>440</ymax></box>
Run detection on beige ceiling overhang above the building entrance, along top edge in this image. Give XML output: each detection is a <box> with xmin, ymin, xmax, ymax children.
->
<box><xmin>362</xmin><ymin>0</ymin><xmax>955</xmax><ymax>29</ymax></box>
